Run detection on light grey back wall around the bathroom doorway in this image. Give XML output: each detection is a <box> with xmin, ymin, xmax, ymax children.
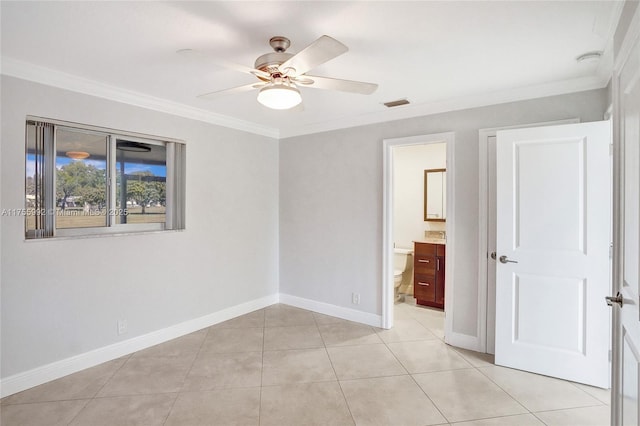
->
<box><xmin>280</xmin><ymin>89</ymin><xmax>606</xmax><ymax>336</ymax></box>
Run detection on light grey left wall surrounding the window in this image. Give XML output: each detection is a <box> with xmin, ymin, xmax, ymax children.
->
<box><xmin>0</xmin><ymin>77</ymin><xmax>278</xmax><ymax>379</ymax></box>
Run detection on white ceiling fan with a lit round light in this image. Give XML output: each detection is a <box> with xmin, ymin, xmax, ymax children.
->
<box><xmin>178</xmin><ymin>35</ymin><xmax>378</xmax><ymax>109</ymax></box>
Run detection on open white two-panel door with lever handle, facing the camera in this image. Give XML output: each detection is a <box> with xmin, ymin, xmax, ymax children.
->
<box><xmin>495</xmin><ymin>122</ymin><xmax>611</xmax><ymax>388</ymax></box>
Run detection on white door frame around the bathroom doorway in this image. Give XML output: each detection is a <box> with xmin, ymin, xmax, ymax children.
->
<box><xmin>381</xmin><ymin>132</ymin><xmax>455</xmax><ymax>330</ymax></box>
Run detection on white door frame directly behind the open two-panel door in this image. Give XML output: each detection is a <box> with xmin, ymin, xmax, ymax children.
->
<box><xmin>476</xmin><ymin>118</ymin><xmax>580</xmax><ymax>353</ymax></box>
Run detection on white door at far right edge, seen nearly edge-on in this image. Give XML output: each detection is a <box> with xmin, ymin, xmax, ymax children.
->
<box><xmin>612</xmin><ymin>8</ymin><xmax>640</xmax><ymax>426</ymax></box>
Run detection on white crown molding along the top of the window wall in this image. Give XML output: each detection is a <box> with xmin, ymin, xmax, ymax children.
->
<box><xmin>0</xmin><ymin>56</ymin><xmax>280</xmax><ymax>139</ymax></box>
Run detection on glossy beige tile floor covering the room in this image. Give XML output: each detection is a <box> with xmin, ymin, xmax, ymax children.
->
<box><xmin>0</xmin><ymin>303</ymin><xmax>609</xmax><ymax>426</ymax></box>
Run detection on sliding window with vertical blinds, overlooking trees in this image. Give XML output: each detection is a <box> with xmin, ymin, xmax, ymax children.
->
<box><xmin>25</xmin><ymin>118</ymin><xmax>185</xmax><ymax>239</ymax></box>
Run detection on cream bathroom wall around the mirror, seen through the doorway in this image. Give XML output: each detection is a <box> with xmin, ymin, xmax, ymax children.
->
<box><xmin>393</xmin><ymin>143</ymin><xmax>447</xmax><ymax>248</ymax></box>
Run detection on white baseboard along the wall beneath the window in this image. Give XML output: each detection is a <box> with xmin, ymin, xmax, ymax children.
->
<box><xmin>0</xmin><ymin>294</ymin><xmax>278</xmax><ymax>398</ymax></box>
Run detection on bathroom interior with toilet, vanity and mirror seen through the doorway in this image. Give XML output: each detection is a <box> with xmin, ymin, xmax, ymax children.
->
<box><xmin>393</xmin><ymin>142</ymin><xmax>447</xmax><ymax>310</ymax></box>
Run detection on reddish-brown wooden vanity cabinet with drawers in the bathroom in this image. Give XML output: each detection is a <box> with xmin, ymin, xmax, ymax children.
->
<box><xmin>413</xmin><ymin>242</ymin><xmax>446</xmax><ymax>309</ymax></box>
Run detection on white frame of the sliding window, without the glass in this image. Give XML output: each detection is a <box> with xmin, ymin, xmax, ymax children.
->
<box><xmin>24</xmin><ymin>116</ymin><xmax>186</xmax><ymax>240</ymax></box>
